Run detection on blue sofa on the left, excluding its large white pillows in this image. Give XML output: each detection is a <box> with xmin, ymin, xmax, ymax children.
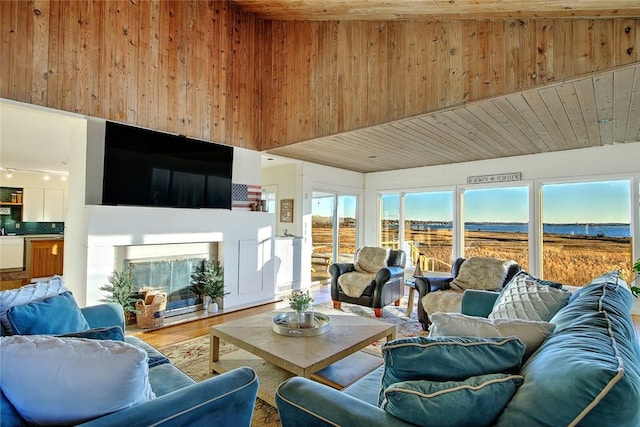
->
<box><xmin>0</xmin><ymin>282</ymin><xmax>258</xmax><ymax>427</ymax></box>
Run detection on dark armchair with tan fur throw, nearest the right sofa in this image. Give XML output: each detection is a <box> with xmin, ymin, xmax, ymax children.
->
<box><xmin>415</xmin><ymin>257</ymin><xmax>522</xmax><ymax>330</ymax></box>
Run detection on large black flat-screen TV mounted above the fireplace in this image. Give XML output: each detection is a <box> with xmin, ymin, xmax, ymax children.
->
<box><xmin>102</xmin><ymin>122</ymin><xmax>233</xmax><ymax>209</ymax></box>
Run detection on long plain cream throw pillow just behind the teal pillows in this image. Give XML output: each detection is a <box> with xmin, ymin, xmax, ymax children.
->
<box><xmin>429</xmin><ymin>313</ymin><xmax>555</xmax><ymax>359</ymax></box>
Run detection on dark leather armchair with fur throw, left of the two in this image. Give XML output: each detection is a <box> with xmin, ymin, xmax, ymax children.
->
<box><xmin>329</xmin><ymin>246</ymin><xmax>406</xmax><ymax>317</ymax></box>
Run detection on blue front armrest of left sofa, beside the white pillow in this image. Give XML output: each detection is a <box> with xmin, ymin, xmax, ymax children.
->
<box><xmin>82</xmin><ymin>367</ymin><xmax>258</xmax><ymax>427</ymax></box>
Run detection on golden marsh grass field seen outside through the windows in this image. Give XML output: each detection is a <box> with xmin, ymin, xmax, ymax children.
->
<box><xmin>312</xmin><ymin>221</ymin><xmax>633</xmax><ymax>286</ymax></box>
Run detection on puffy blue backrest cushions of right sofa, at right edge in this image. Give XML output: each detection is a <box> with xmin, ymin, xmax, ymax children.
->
<box><xmin>497</xmin><ymin>272</ymin><xmax>640</xmax><ymax>427</ymax></box>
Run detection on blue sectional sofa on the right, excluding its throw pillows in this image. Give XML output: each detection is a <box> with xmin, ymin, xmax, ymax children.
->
<box><xmin>276</xmin><ymin>272</ymin><xmax>640</xmax><ymax>427</ymax></box>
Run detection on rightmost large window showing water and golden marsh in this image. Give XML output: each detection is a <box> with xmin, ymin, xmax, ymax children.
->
<box><xmin>542</xmin><ymin>180</ymin><xmax>633</xmax><ymax>286</ymax></box>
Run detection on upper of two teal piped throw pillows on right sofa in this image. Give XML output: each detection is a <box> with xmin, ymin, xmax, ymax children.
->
<box><xmin>378</xmin><ymin>337</ymin><xmax>525</xmax><ymax>403</ymax></box>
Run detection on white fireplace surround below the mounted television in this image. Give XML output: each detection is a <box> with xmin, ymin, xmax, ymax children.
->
<box><xmin>82</xmin><ymin>205</ymin><xmax>275</xmax><ymax>309</ymax></box>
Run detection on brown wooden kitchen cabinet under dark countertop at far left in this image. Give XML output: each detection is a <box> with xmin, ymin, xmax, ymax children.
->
<box><xmin>26</xmin><ymin>238</ymin><xmax>64</xmax><ymax>279</ymax></box>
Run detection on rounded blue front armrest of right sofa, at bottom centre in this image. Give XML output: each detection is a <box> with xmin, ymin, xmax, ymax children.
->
<box><xmin>276</xmin><ymin>377</ymin><xmax>413</xmax><ymax>427</ymax></box>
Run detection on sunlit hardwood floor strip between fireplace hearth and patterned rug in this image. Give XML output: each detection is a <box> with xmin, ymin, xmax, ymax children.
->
<box><xmin>127</xmin><ymin>285</ymin><xmax>331</xmax><ymax>347</ymax></box>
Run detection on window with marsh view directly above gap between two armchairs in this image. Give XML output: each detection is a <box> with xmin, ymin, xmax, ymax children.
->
<box><xmin>404</xmin><ymin>191</ymin><xmax>453</xmax><ymax>272</ymax></box>
